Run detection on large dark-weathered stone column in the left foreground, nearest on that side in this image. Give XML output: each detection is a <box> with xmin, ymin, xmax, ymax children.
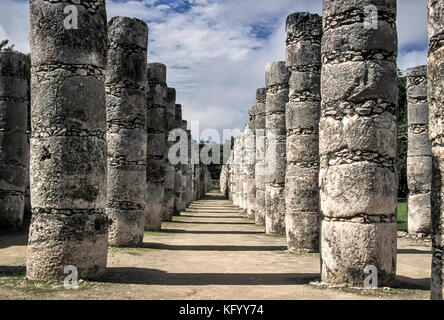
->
<box><xmin>27</xmin><ymin>0</ymin><xmax>108</xmax><ymax>280</ymax></box>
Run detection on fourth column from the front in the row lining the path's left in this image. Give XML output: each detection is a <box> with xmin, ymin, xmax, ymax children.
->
<box><xmin>162</xmin><ymin>88</ymin><xmax>176</xmax><ymax>221</ymax></box>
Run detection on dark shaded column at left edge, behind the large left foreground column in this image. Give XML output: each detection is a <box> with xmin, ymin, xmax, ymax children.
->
<box><xmin>0</xmin><ymin>52</ymin><xmax>29</xmax><ymax>229</ymax></box>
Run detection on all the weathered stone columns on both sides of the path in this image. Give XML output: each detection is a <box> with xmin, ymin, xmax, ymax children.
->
<box><xmin>0</xmin><ymin>0</ymin><xmax>444</xmax><ymax>299</ymax></box>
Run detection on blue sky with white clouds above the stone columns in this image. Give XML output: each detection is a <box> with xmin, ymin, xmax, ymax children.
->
<box><xmin>0</xmin><ymin>0</ymin><xmax>427</xmax><ymax>140</ymax></box>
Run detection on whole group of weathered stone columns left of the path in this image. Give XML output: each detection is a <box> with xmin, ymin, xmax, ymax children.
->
<box><xmin>12</xmin><ymin>0</ymin><xmax>215</xmax><ymax>280</ymax></box>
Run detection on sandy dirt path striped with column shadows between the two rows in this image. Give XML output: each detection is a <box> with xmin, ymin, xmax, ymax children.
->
<box><xmin>0</xmin><ymin>193</ymin><xmax>431</xmax><ymax>300</ymax></box>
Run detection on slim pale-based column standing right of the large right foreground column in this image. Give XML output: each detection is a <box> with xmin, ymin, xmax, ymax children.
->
<box><xmin>407</xmin><ymin>66</ymin><xmax>432</xmax><ymax>235</ymax></box>
